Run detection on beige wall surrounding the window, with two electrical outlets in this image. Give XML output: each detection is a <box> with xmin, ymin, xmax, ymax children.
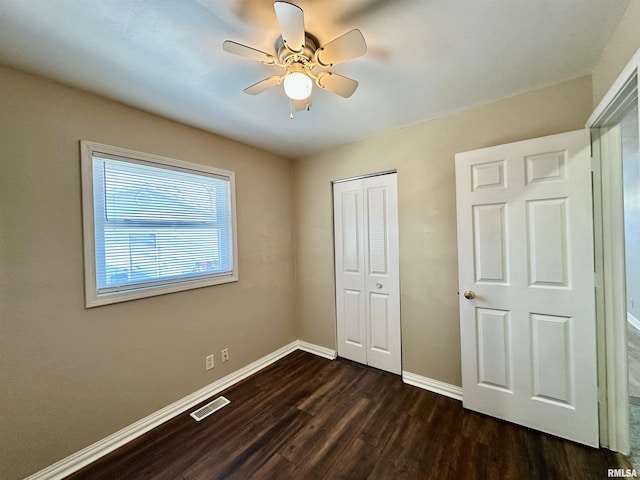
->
<box><xmin>0</xmin><ymin>66</ymin><xmax>296</xmax><ymax>480</ymax></box>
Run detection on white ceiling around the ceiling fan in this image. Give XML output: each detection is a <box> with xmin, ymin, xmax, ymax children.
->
<box><xmin>0</xmin><ymin>0</ymin><xmax>629</xmax><ymax>158</ymax></box>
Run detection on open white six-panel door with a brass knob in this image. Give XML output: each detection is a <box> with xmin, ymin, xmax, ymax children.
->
<box><xmin>456</xmin><ymin>130</ymin><xmax>599</xmax><ymax>447</ymax></box>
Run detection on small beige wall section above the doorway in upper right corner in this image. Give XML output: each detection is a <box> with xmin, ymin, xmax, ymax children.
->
<box><xmin>592</xmin><ymin>0</ymin><xmax>640</xmax><ymax>108</ymax></box>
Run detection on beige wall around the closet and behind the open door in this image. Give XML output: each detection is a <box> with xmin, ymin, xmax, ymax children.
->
<box><xmin>294</xmin><ymin>77</ymin><xmax>592</xmax><ymax>385</ymax></box>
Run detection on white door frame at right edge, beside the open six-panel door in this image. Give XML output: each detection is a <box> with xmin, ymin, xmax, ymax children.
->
<box><xmin>586</xmin><ymin>49</ymin><xmax>640</xmax><ymax>454</ymax></box>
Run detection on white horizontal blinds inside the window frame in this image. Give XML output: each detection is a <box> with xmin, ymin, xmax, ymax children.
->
<box><xmin>93</xmin><ymin>154</ymin><xmax>234</xmax><ymax>294</ymax></box>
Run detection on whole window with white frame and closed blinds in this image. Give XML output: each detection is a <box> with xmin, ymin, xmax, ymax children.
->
<box><xmin>81</xmin><ymin>141</ymin><xmax>238</xmax><ymax>307</ymax></box>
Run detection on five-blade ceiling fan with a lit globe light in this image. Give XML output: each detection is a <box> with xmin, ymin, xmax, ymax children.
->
<box><xmin>222</xmin><ymin>2</ymin><xmax>367</xmax><ymax>118</ymax></box>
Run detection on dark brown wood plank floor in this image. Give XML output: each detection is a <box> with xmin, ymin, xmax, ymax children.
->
<box><xmin>68</xmin><ymin>351</ymin><xmax>629</xmax><ymax>480</ymax></box>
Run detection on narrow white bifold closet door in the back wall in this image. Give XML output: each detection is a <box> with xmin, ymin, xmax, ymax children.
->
<box><xmin>333</xmin><ymin>174</ymin><xmax>402</xmax><ymax>374</ymax></box>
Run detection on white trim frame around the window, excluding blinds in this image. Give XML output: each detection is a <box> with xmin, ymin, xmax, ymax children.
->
<box><xmin>80</xmin><ymin>140</ymin><xmax>238</xmax><ymax>308</ymax></box>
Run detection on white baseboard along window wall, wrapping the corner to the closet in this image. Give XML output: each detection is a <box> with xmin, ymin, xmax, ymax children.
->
<box><xmin>25</xmin><ymin>340</ymin><xmax>336</xmax><ymax>480</ymax></box>
